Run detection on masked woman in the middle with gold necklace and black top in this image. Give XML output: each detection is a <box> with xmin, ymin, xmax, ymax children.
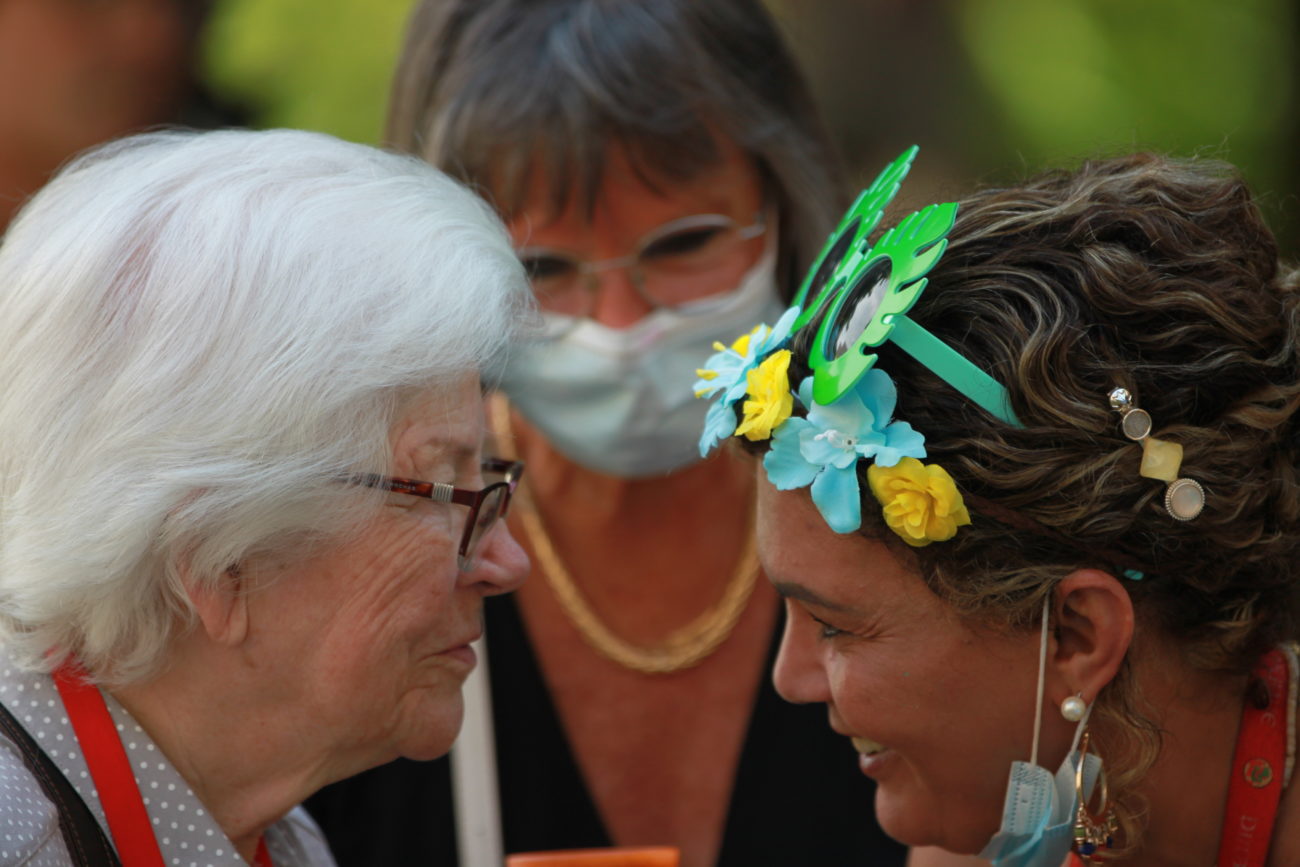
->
<box><xmin>313</xmin><ymin>0</ymin><xmax>902</xmax><ymax>867</ymax></box>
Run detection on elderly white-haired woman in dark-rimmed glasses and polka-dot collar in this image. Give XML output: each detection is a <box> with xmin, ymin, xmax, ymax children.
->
<box><xmin>0</xmin><ymin>131</ymin><xmax>529</xmax><ymax>867</ymax></box>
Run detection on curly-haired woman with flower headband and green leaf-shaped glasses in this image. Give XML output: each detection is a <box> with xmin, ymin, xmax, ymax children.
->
<box><xmin>706</xmin><ymin>145</ymin><xmax>1300</xmax><ymax>867</ymax></box>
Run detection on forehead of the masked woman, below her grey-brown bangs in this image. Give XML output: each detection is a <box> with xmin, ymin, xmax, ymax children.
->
<box><xmin>507</xmin><ymin>133</ymin><xmax>763</xmax><ymax>246</ymax></box>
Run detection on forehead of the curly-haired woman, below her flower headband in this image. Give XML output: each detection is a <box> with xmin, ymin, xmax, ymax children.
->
<box><xmin>758</xmin><ymin>472</ymin><xmax>939</xmax><ymax>608</ymax></box>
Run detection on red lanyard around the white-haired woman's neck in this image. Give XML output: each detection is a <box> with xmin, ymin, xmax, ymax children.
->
<box><xmin>55</xmin><ymin>664</ymin><xmax>272</xmax><ymax>867</ymax></box>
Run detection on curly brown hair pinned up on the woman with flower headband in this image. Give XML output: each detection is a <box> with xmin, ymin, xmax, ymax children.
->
<box><xmin>764</xmin><ymin>153</ymin><xmax>1300</xmax><ymax>846</ymax></box>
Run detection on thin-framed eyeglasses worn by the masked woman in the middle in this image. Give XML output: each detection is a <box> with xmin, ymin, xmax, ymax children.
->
<box><xmin>516</xmin><ymin>213</ymin><xmax>767</xmax><ymax>317</ymax></box>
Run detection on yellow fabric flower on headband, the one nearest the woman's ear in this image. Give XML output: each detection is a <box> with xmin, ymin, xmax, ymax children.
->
<box><xmin>867</xmin><ymin>458</ymin><xmax>971</xmax><ymax>547</ymax></box>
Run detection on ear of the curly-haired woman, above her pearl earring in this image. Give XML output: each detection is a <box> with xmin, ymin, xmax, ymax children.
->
<box><xmin>1045</xmin><ymin>569</ymin><xmax>1134</xmax><ymax>706</ymax></box>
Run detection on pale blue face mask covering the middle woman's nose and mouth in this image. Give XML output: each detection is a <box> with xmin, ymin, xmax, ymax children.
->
<box><xmin>502</xmin><ymin>231</ymin><xmax>784</xmax><ymax>478</ymax></box>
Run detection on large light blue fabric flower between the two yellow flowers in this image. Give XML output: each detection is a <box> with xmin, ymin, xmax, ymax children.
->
<box><xmin>763</xmin><ymin>368</ymin><xmax>926</xmax><ymax>533</ymax></box>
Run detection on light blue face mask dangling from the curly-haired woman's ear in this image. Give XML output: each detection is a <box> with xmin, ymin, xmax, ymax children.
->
<box><xmin>979</xmin><ymin>594</ymin><xmax>1101</xmax><ymax>867</ymax></box>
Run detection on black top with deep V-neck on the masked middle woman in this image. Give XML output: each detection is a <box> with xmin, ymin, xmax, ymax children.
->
<box><xmin>307</xmin><ymin>595</ymin><xmax>906</xmax><ymax>867</ymax></box>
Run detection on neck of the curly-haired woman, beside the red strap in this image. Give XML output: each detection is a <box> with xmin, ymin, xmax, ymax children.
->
<box><xmin>1112</xmin><ymin>644</ymin><xmax>1245</xmax><ymax>867</ymax></box>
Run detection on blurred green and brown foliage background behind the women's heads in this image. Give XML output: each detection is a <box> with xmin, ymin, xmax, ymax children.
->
<box><xmin>204</xmin><ymin>0</ymin><xmax>1300</xmax><ymax>250</ymax></box>
